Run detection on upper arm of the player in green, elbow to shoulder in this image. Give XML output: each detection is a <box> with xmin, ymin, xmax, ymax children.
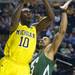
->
<box><xmin>48</xmin><ymin>32</ymin><xmax>65</xmax><ymax>56</ymax></box>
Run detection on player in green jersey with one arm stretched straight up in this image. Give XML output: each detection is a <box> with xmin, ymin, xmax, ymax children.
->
<box><xmin>31</xmin><ymin>0</ymin><xmax>72</xmax><ymax>75</ymax></box>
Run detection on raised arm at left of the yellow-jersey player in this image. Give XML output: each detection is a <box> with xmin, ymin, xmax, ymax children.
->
<box><xmin>10</xmin><ymin>3</ymin><xmax>23</xmax><ymax>32</ymax></box>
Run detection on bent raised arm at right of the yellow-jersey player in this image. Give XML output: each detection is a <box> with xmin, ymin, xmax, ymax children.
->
<box><xmin>36</xmin><ymin>0</ymin><xmax>54</xmax><ymax>32</ymax></box>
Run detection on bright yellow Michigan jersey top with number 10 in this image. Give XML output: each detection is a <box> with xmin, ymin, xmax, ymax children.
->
<box><xmin>4</xmin><ymin>24</ymin><xmax>36</xmax><ymax>64</ymax></box>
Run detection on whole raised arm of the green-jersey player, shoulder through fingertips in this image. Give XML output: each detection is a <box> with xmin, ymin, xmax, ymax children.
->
<box><xmin>46</xmin><ymin>0</ymin><xmax>71</xmax><ymax>60</ymax></box>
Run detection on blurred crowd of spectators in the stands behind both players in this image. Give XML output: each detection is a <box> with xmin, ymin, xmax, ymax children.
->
<box><xmin>0</xmin><ymin>0</ymin><xmax>75</xmax><ymax>75</ymax></box>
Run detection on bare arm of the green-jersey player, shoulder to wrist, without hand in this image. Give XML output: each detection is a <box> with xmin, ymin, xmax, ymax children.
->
<box><xmin>45</xmin><ymin>12</ymin><xmax>68</xmax><ymax>60</ymax></box>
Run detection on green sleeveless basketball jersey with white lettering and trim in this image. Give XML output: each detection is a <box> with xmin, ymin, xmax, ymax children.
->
<box><xmin>32</xmin><ymin>52</ymin><xmax>54</xmax><ymax>75</ymax></box>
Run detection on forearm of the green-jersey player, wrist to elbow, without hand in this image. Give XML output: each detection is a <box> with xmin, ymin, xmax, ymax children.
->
<box><xmin>59</xmin><ymin>12</ymin><xmax>68</xmax><ymax>33</ymax></box>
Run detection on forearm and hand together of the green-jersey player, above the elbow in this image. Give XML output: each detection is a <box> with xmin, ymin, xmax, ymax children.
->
<box><xmin>59</xmin><ymin>0</ymin><xmax>72</xmax><ymax>33</ymax></box>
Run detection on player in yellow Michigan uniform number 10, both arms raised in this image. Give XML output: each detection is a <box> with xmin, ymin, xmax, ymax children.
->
<box><xmin>0</xmin><ymin>0</ymin><xmax>54</xmax><ymax>75</ymax></box>
